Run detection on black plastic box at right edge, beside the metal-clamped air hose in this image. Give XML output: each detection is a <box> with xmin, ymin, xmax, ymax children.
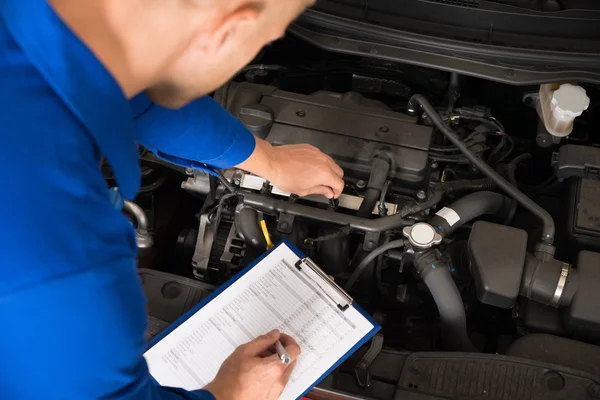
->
<box><xmin>565</xmin><ymin>251</ymin><xmax>600</xmax><ymax>338</ymax></box>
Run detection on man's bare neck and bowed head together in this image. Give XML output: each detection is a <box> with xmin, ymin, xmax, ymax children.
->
<box><xmin>48</xmin><ymin>0</ymin><xmax>315</xmax><ymax>107</ymax></box>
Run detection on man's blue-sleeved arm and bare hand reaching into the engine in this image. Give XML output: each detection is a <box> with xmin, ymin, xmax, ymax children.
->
<box><xmin>132</xmin><ymin>95</ymin><xmax>344</xmax><ymax>198</ymax></box>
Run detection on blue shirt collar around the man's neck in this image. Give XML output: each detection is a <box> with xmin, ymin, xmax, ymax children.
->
<box><xmin>0</xmin><ymin>0</ymin><xmax>140</xmax><ymax>199</ymax></box>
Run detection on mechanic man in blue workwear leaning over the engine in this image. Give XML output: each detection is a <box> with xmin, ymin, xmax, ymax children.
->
<box><xmin>0</xmin><ymin>0</ymin><xmax>343</xmax><ymax>400</ymax></box>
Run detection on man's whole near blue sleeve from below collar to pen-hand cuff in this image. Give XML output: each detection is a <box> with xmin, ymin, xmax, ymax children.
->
<box><xmin>0</xmin><ymin>39</ymin><xmax>214</xmax><ymax>400</ymax></box>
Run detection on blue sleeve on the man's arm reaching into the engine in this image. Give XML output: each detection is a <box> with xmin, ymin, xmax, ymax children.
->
<box><xmin>131</xmin><ymin>94</ymin><xmax>256</xmax><ymax>169</ymax></box>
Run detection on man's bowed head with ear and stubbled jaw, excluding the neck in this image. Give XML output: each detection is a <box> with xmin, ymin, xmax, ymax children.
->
<box><xmin>147</xmin><ymin>0</ymin><xmax>314</xmax><ymax>107</ymax></box>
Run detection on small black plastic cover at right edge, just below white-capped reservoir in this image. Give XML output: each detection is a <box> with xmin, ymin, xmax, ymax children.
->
<box><xmin>555</xmin><ymin>144</ymin><xmax>600</xmax><ymax>180</ymax></box>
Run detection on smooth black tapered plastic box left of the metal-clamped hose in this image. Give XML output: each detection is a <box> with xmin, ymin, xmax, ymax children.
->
<box><xmin>469</xmin><ymin>221</ymin><xmax>527</xmax><ymax>308</ymax></box>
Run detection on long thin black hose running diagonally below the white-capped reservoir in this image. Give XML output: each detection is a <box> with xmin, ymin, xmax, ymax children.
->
<box><xmin>409</xmin><ymin>94</ymin><xmax>556</xmax><ymax>244</ymax></box>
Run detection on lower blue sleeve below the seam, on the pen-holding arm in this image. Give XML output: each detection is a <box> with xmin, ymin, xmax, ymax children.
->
<box><xmin>0</xmin><ymin>257</ymin><xmax>214</xmax><ymax>400</ymax></box>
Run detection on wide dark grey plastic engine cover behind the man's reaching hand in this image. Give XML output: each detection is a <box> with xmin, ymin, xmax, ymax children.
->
<box><xmin>227</xmin><ymin>83</ymin><xmax>433</xmax><ymax>188</ymax></box>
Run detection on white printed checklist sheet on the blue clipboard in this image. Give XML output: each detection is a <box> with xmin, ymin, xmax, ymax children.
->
<box><xmin>144</xmin><ymin>245</ymin><xmax>373</xmax><ymax>400</ymax></box>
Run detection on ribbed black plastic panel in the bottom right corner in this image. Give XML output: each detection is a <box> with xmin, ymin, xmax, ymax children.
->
<box><xmin>396</xmin><ymin>353</ymin><xmax>600</xmax><ymax>400</ymax></box>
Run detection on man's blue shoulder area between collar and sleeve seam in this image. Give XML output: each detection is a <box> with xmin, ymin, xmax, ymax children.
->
<box><xmin>0</xmin><ymin>23</ymin><xmax>135</xmax><ymax>296</ymax></box>
